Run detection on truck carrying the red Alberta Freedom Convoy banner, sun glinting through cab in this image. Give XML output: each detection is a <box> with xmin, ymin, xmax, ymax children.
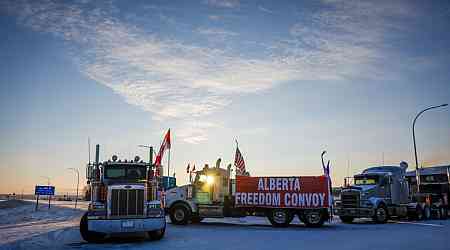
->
<box><xmin>166</xmin><ymin>165</ymin><xmax>331</xmax><ymax>227</ymax></box>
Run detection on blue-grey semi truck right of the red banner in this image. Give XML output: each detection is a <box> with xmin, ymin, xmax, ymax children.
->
<box><xmin>335</xmin><ymin>162</ymin><xmax>430</xmax><ymax>223</ymax></box>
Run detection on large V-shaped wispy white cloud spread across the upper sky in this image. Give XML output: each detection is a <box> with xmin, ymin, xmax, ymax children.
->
<box><xmin>0</xmin><ymin>0</ymin><xmax>422</xmax><ymax>143</ymax></box>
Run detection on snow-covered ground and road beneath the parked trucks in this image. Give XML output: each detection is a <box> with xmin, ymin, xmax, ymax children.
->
<box><xmin>0</xmin><ymin>201</ymin><xmax>450</xmax><ymax>250</ymax></box>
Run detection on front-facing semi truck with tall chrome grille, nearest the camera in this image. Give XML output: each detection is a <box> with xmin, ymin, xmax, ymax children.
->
<box><xmin>80</xmin><ymin>145</ymin><xmax>166</xmax><ymax>242</ymax></box>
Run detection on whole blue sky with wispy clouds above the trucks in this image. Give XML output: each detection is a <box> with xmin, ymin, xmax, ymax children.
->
<box><xmin>0</xmin><ymin>0</ymin><xmax>450</xmax><ymax>194</ymax></box>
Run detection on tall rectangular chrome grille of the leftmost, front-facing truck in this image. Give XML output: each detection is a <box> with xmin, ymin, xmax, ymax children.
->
<box><xmin>110</xmin><ymin>189</ymin><xmax>144</xmax><ymax>217</ymax></box>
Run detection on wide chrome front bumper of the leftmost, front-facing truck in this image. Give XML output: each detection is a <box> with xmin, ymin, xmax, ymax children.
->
<box><xmin>88</xmin><ymin>217</ymin><xmax>166</xmax><ymax>234</ymax></box>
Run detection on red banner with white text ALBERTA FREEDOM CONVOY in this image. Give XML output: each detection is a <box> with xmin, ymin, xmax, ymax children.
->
<box><xmin>235</xmin><ymin>176</ymin><xmax>329</xmax><ymax>208</ymax></box>
